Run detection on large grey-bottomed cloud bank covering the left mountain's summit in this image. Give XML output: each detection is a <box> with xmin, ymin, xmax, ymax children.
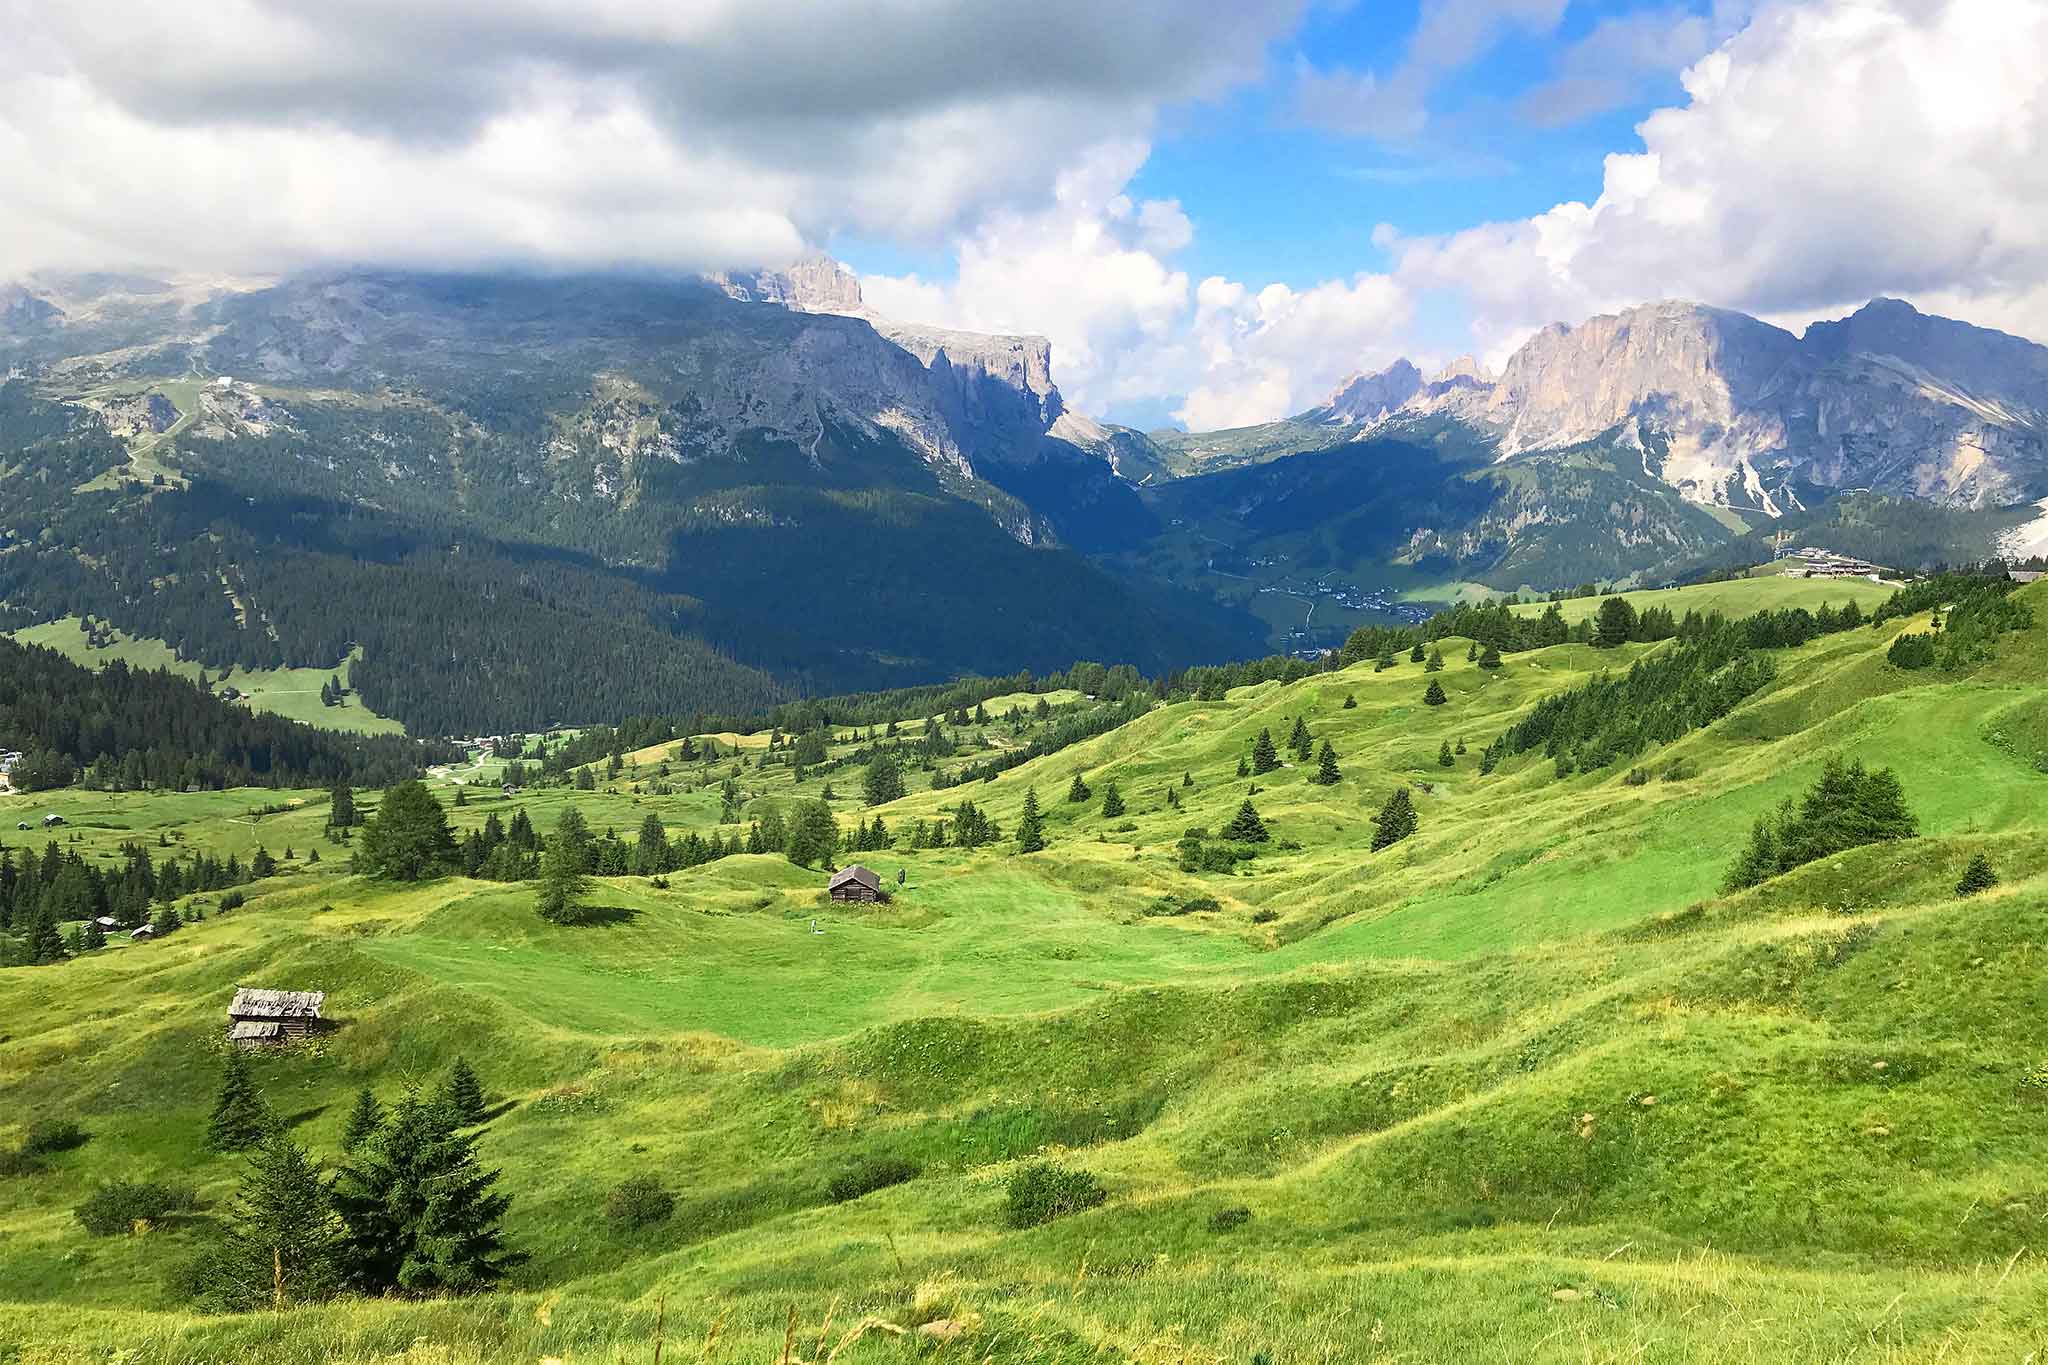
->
<box><xmin>0</xmin><ymin>0</ymin><xmax>1303</xmax><ymax>272</ymax></box>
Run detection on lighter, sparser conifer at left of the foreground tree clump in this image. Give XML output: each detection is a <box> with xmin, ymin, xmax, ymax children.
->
<box><xmin>201</xmin><ymin>1130</ymin><xmax>344</xmax><ymax>1312</ymax></box>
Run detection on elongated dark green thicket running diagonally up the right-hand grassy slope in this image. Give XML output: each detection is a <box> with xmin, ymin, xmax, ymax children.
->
<box><xmin>1479</xmin><ymin>604</ymin><xmax>1864</xmax><ymax>776</ymax></box>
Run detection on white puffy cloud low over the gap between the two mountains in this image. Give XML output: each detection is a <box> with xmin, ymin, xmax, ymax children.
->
<box><xmin>860</xmin><ymin>143</ymin><xmax>1409</xmax><ymax>428</ymax></box>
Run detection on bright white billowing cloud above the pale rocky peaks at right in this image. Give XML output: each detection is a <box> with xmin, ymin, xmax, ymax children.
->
<box><xmin>1389</xmin><ymin>0</ymin><xmax>2048</xmax><ymax>356</ymax></box>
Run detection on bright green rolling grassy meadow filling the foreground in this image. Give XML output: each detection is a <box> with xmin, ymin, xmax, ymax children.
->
<box><xmin>0</xmin><ymin>581</ymin><xmax>2048</xmax><ymax>1363</ymax></box>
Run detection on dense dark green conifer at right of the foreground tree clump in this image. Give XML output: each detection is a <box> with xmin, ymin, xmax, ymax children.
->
<box><xmin>334</xmin><ymin>1093</ymin><xmax>524</xmax><ymax>1293</ymax></box>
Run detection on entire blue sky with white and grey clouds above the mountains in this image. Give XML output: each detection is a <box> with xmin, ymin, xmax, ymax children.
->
<box><xmin>0</xmin><ymin>0</ymin><xmax>2048</xmax><ymax>430</ymax></box>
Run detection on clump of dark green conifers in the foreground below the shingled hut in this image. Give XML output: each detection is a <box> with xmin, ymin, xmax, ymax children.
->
<box><xmin>177</xmin><ymin>1050</ymin><xmax>524</xmax><ymax>1312</ymax></box>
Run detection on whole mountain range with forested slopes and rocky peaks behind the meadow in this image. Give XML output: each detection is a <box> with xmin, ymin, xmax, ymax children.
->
<box><xmin>0</xmin><ymin>258</ymin><xmax>2048</xmax><ymax>733</ymax></box>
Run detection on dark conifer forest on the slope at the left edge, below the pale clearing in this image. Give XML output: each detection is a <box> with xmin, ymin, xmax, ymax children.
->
<box><xmin>0</xmin><ymin>639</ymin><xmax>453</xmax><ymax>792</ymax></box>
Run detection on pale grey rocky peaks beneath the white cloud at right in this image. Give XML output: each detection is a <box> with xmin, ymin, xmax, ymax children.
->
<box><xmin>1305</xmin><ymin>299</ymin><xmax>2048</xmax><ymax>516</ymax></box>
